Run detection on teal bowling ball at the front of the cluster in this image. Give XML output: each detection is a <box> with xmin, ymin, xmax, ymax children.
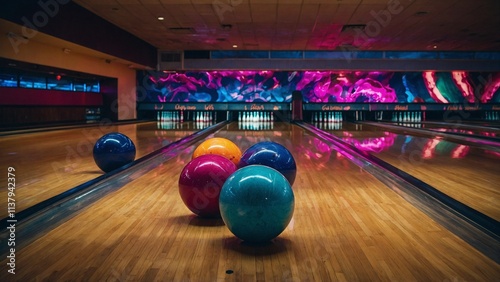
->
<box><xmin>219</xmin><ymin>165</ymin><xmax>295</xmax><ymax>243</ymax></box>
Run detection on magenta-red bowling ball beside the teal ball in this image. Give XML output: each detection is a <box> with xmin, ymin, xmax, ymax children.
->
<box><xmin>179</xmin><ymin>154</ymin><xmax>237</xmax><ymax>217</ymax></box>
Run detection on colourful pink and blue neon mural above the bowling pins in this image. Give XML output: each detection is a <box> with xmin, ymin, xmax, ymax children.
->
<box><xmin>138</xmin><ymin>70</ymin><xmax>500</xmax><ymax>103</ymax></box>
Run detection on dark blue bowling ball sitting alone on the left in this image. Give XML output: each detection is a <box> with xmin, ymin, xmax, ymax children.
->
<box><xmin>93</xmin><ymin>132</ymin><xmax>136</xmax><ymax>172</ymax></box>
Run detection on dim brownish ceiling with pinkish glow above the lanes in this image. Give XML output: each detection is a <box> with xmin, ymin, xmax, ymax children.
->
<box><xmin>74</xmin><ymin>0</ymin><xmax>500</xmax><ymax>51</ymax></box>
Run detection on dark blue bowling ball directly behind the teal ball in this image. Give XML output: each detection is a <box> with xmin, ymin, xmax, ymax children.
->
<box><xmin>238</xmin><ymin>141</ymin><xmax>297</xmax><ymax>185</ymax></box>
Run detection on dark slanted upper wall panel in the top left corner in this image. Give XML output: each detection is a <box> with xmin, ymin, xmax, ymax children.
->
<box><xmin>0</xmin><ymin>0</ymin><xmax>157</xmax><ymax>68</ymax></box>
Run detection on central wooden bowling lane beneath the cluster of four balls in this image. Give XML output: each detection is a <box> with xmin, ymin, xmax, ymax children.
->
<box><xmin>0</xmin><ymin>123</ymin><xmax>500</xmax><ymax>281</ymax></box>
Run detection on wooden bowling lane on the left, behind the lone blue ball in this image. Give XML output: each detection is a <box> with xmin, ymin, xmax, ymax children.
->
<box><xmin>0</xmin><ymin>122</ymin><xmax>194</xmax><ymax>218</ymax></box>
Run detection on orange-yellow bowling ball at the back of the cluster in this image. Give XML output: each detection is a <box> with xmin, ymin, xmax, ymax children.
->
<box><xmin>192</xmin><ymin>137</ymin><xmax>241</xmax><ymax>165</ymax></box>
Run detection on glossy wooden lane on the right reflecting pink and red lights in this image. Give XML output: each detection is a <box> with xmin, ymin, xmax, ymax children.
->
<box><xmin>324</xmin><ymin>123</ymin><xmax>500</xmax><ymax>220</ymax></box>
